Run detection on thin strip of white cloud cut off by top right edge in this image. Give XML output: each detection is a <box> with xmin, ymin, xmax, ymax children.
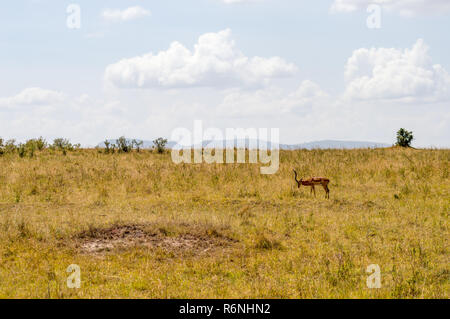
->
<box><xmin>330</xmin><ymin>0</ymin><xmax>450</xmax><ymax>16</ymax></box>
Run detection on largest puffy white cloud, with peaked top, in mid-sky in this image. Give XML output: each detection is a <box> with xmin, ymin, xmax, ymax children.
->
<box><xmin>105</xmin><ymin>29</ymin><xmax>297</xmax><ymax>88</ymax></box>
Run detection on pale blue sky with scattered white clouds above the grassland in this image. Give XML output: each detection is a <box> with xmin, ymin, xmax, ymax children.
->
<box><xmin>0</xmin><ymin>0</ymin><xmax>450</xmax><ymax>147</ymax></box>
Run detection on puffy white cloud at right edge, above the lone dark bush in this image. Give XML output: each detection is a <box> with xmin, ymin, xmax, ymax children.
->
<box><xmin>345</xmin><ymin>39</ymin><xmax>450</xmax><ymax>102</ymax></box>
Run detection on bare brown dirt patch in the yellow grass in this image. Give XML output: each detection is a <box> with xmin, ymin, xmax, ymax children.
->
<box><xmin>75</xmin><ymin>224</ymin><xmax>237</xmax><ymax>254</ymax></box>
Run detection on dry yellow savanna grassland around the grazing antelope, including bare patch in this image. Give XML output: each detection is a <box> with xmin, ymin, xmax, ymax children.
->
<box><xmin>0</xmin><ymin>148</ymin><xmax>450</xmax><ymax>298</ymax></box>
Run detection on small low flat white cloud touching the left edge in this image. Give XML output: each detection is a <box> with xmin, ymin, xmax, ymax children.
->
<box><xmin>0</xmin><ymin>87</ymin><xmax>64</xmax><ymax>108</ymax></box>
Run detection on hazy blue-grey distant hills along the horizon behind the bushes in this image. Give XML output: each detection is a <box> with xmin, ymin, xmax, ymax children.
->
<box><xmin>97</xmin><ymin>139</ymin><xmax>391</xmax><ymax>150</ymax></box>
